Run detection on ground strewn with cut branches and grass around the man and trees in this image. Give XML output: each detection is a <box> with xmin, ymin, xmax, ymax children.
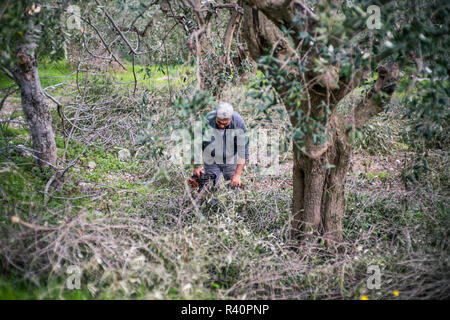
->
<box><xmin>0</xmin><ymin>62</ymin><xmax>450</xmax><ymax>299</ymax></box>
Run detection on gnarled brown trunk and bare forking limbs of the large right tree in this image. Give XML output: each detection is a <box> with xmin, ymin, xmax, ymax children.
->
<box><xmin>243</xmin><ymin>0</ymin><xmax>398</xmax><ymax>244</ymax></box>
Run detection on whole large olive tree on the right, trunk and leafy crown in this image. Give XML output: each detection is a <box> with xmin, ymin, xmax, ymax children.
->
<box><xmin>234</xmin><ymin>0</ymin><xmax>449</xmax><ymax>243</ymax></box>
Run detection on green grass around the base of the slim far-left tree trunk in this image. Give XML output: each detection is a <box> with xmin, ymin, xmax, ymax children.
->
<box><xmin>0</xmin><ymin>116</ymin><xmax>142</xmax><ymax>222</ymax></box>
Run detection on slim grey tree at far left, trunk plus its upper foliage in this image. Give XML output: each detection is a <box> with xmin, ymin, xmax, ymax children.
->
<box><xmin>0</xmin><ymin>0</ymin><xmax>66</xmax><ymax>167</ymax></box>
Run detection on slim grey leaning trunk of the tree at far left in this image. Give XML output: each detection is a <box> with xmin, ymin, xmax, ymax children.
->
<box><xmin>13</xmin><ymin>18</ymin><xmax>57</xmax><ymax>167</ymax></box>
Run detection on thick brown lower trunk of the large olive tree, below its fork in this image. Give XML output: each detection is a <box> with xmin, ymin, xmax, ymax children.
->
<box><xmin>291</xmin><ymin>119</ymin><xmax>351</xmax><ymax>244</ymax></box>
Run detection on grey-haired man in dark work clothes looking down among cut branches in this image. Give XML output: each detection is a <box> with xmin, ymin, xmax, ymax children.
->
<box><xmin>194</xmin><ymin>102</ymin><xmax>249</xmax><ymax>187</ymax></box>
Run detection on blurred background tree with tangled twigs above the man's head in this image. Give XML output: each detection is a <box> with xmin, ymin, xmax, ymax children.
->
<box><xmin>160</xmin><ymin>0</ymin><xmax>249</xmax><ymax>97</ymax></box>
